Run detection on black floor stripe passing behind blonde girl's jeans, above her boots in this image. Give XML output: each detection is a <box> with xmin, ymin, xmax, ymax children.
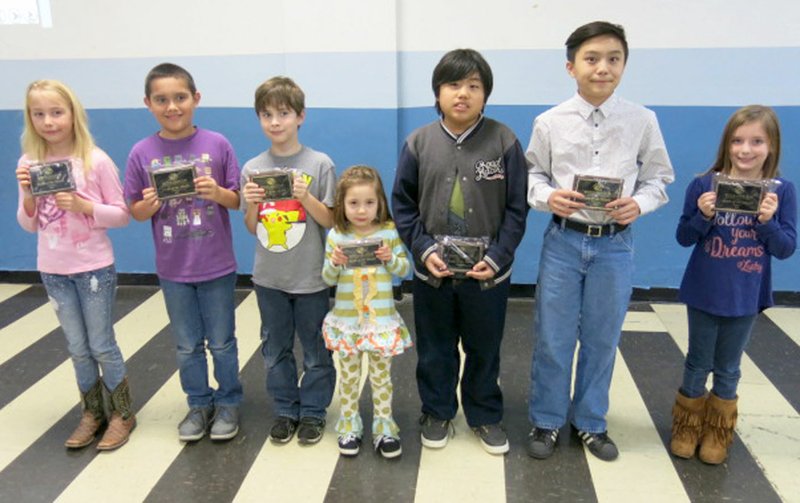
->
<box><xmin>0</xmin><ymin>287</ymin><xmax>155</xmax><ymax>408</ymax></box>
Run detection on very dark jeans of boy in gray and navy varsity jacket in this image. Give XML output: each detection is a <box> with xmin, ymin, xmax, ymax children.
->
<box><xmin>413</xmin><ymin>276</ymin><xmax>509</xmax><ymax>427</ymax></box>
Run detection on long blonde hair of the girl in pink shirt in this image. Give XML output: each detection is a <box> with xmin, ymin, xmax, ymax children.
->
<box><xmin>21</xmin><ymin>79</ymin><xmax>95</xmax><ymax>173</ymax></box>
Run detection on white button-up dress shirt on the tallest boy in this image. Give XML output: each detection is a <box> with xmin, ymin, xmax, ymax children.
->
<box><xmin>525</xmin><ymin>94</ymin><xmax>675</xmax><ymax>224</ymax></box>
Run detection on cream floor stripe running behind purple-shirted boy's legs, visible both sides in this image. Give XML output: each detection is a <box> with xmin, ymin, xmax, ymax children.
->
<box><xmin>57</xmin><ymin>294</ymin><xmax>259</xmax><ymax>502</ymax></box>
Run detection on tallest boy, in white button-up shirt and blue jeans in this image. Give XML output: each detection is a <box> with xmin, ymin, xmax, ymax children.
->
<box><xmin>526</xmin><ymin>21</ymin><xmax>674</xmax><ymax>461</ymax></box>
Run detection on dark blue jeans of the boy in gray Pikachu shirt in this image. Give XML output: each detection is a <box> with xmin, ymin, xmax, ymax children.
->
<box><xmin>255</xmin><ymin>285</ymin><xmax>336</xmax><ymax>419</ymax></box>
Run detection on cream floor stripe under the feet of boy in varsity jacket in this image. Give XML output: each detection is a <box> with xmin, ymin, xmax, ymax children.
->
<box><xmin>406</xmin><ymin>347</ymin><xmax>506</xmax><ymax>503</ymax></box>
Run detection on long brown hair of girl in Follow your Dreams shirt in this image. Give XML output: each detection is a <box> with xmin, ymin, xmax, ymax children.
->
<box><xmin>707</xmin><ymin>105</ymin><xmax>781</xmax><ymax>178</ymax></box>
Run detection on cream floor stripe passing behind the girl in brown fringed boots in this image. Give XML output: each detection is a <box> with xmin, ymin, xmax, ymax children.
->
<box><xmin>653</xmin><ymin>305</ymin><xmax>800</xmax><ymax>501</ymax></box>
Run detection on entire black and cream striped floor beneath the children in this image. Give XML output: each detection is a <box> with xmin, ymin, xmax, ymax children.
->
<box><xmin>0</xmin><ymin>284</ymin><xmax>800</xmax><ymax>503</ymax></box>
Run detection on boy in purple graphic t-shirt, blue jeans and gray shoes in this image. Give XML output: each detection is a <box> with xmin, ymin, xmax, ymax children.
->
<box><xmin>125</xmin><ymin>63</ymin><xmax>242</xmax><ymax>442</ymax></box>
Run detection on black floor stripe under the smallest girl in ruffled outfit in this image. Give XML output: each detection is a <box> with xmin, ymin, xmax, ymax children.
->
<box><xmin>325</xmin><ymin>297</ymin><xmax>422</xmax><ymax>503</ymax></box>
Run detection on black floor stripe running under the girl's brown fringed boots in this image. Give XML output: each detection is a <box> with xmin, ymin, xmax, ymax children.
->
<box><xmin>611</xmin><ymin>332</ymin><xmax>780</xmax><ymax>503</ymax></box>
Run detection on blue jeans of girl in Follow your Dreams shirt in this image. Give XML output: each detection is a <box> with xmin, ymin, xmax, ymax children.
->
<box><xmin>681</xmin><ymin>307</ymin><xmax>758</xmax><ymax>400</ymax></box>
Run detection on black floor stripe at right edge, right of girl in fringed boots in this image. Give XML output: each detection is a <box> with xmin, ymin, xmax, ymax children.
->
<box><xmin>742</xmin><ymin>315</ymin><xmax>800</xmax><ymax>412</ymax></box>
